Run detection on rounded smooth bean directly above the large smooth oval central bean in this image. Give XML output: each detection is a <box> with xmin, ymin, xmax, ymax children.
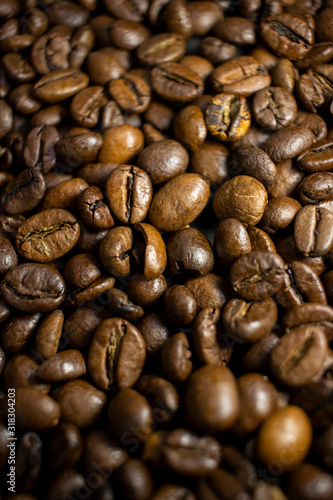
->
<box><xmin>138</xmin><ymin>139</ymin><xmax>189</xmax><ymax>185</ymax></box>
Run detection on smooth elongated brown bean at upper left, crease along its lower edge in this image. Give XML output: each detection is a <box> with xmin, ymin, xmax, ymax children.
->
<box><xmin>34</xmin><ymin>69</ymin><xmax>89</xmax><ymax>104</ymax></box>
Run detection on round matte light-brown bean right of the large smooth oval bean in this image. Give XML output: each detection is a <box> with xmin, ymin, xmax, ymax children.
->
<box><xmin>213</xmin><ymin>175</ymin><xmax>268</xmax><ymax>226</ymax></box>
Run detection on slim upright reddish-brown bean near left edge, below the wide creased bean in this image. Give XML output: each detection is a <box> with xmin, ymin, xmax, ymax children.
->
<box><xmin>35</xmin><ymin>309</ymin><xmax>64</xmax><ymax>359</ymax></box>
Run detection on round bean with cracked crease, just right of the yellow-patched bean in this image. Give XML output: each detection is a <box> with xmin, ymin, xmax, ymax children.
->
<box><xmin>253</xmin><ymin>87</ymin><xmax>297</xmax><ymax>131</ymax></box>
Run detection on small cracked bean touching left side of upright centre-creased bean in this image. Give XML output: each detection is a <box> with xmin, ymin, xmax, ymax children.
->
<box><xmin>77</xmin><ymin>186</ymin><xmax>114</xmax><ymax>230</ymax></box>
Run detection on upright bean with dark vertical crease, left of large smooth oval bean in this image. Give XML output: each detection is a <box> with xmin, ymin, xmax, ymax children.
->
<box><xmin>105</xmin><ymin>165</ymin><xmax>153</xmax><ymax>224</ymax></box>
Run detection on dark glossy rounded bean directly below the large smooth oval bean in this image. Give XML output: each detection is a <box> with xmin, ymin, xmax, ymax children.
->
<box><xmin>167</xmin><ymin>227</ymin><xmax>214</xmax><ymax>276</ymax></box>
